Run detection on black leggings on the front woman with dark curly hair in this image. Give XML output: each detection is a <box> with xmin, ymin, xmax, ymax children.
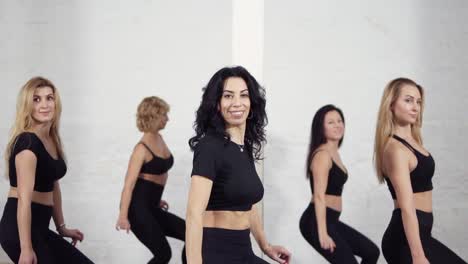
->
<box><xmin>202</xmin><ymin>227</ymin><xmax>268</xmax><ymax>264</ymax></box>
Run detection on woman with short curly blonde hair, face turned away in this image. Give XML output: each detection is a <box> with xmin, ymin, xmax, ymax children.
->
<box><xmin>116</xmin><ymin>96</ymin><xmax>186</xmax><ymax>264</ymax></box>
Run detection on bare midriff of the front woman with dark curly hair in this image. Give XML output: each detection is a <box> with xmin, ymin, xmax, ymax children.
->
<box><xmin>203</xmin><ymin>211</ymin><xmax>251</xmax><ymax>230</ymax></box>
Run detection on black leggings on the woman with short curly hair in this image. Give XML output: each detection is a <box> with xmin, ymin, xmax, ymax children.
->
<box><xmin>128</xmin><ymin>178</ymin><xmax>187</xmax><ymax>264</ymax></box>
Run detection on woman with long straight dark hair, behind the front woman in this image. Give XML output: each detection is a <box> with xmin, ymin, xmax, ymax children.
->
<box><xmin>299</xmin><ymin>105</ymin><xmax>380</xmax><ymax>264</ymax></box>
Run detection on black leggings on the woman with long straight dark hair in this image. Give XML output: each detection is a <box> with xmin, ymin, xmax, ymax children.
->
<box><xmin>299</xmin><ymin>203</ymin><xmax>380</xmax><ymax>264</ymax></box>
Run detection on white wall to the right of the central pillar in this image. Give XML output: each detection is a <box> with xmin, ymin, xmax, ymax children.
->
<box><xmin>264</xmin><ymin>0</ymin><xmax>468</xmax><ymax>263</ymax></box>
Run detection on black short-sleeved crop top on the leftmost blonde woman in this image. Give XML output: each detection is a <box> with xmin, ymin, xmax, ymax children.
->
<box><xmin>8</xmin><ymin>132</ymin><xmax>67</xmax><ymax>192</ymax></box>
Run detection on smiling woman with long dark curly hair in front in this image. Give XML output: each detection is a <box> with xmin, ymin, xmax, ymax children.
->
<box><xmin>186</xmin><ymin>66</ymin><xmax>290</xmax><ymax>264</ymax></box>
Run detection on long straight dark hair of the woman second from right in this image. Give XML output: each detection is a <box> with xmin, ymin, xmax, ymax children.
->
<box><xmin>306</xmin><ymin>104</ymin><xmax>345</xmax><ymax>178</ymax></box>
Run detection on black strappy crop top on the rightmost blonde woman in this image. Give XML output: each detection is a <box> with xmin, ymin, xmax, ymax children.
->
<box><xmin>384</xmin><ymin>135</ymin><xmax>435</xmax><ymax>199</ymax></box>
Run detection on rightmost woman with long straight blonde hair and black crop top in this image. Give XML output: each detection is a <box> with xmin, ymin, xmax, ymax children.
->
<box><xmin>374</xmin><ymin>78</ymin><xmax>466</xmax><ymax>264</ymax></box>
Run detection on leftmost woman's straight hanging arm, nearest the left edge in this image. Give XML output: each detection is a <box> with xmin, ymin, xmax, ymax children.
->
<box><xmin>15</xmin><ymin>150</ymin><xmax>37</xmax><ymax>263</ymax></box>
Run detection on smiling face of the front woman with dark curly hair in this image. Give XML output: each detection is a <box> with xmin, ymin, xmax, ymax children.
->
<box><xmin>218</xmin><ymin>77</ymin><xmax>250</xmax><ymax>127</ymax></box>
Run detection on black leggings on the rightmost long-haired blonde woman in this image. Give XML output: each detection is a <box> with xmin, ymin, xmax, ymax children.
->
<box><xmin>382</xmin><ymin>209</ymin><xmax>466</xmax><ymax>264</ymax></box>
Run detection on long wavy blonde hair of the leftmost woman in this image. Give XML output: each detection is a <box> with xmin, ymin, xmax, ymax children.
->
<box><xmin>4</xmin><ymin>77</ymin><xmax>65</xmax><ymax>177</ymax></box>
